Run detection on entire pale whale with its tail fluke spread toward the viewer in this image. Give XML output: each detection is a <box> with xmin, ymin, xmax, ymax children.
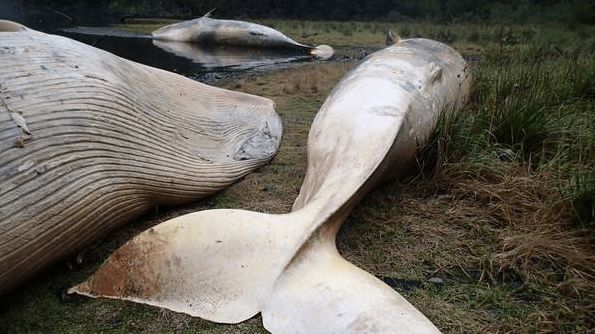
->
<box><xmin>70</xmin><ymin>30</ymin><xmax>470</xmax><ymax>333</ymax></box>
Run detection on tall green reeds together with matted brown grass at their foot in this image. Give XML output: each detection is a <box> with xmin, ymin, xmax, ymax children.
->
<box><xmin>420</xmin><ymin>33</ymin><xmax>595</xmax><ymax>306</ymax></box>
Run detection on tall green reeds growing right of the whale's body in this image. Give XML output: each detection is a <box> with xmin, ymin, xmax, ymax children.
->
<box><xmin>428</xmin><ymin>37</ymin><xmax>595</xmax><ymax>215</ymax></box>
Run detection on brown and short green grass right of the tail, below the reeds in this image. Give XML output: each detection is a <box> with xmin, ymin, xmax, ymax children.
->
<box><xmin>338</xmin><ymin>161</ymin><xmax>595</xmax><ymax>333</ymax></box>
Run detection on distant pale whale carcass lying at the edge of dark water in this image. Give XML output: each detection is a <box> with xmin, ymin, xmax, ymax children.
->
<box><xmin>152</xmin><ymin>11</ymin><xmax>334</xmax><ymax>59</ymax></box>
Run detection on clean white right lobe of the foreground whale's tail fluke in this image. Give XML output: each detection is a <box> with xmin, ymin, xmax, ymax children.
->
<box><xmin>262</xmin><ymin>231</ymin><xmax>440</xmax><ymax>334</ymax></box>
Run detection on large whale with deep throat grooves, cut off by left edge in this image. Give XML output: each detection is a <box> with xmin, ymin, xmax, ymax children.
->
<box><xmin>0</xmin><ymin>21</ymin><xmax>282</xmax><ymax>295</ymax></box>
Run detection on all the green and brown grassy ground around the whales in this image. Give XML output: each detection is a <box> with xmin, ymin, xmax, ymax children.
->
<box><xmin>0</xmin><ymin>20</ymin><xmax>595</xmax><ymax>333</ymax></box>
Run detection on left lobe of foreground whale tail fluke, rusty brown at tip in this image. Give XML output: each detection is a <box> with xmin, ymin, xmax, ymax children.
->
<box><xmin>68</xmin><ymin>209</ymin><xmax>300</xmax><ymax>323</ymax></box>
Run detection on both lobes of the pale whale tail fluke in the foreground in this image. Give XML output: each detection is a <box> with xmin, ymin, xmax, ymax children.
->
<box><xmin>68</xmin><ymin>209</ymin><xmax>440</xmax><ymax>334</ymax></box>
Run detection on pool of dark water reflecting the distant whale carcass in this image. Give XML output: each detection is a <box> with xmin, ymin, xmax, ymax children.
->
<box><xmin>54</xmin><ymin>27</ymin><xmax>316</xmax><ymax>83</ymax></box>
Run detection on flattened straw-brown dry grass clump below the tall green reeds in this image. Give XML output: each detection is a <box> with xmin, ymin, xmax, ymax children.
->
<box><xmin>451</xmin><ymin>166</ymin><xmax>595</xmax><ymax>290</ymax></box>
